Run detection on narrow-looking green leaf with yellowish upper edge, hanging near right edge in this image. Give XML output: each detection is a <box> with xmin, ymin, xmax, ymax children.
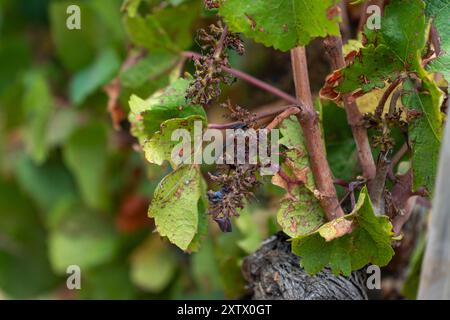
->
<box><xmin>402</xmin><ymin>77</ymin><xmax>443</xmax><ymax>192</ymax></box>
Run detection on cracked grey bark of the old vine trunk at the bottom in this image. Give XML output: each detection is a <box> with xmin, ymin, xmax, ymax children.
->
<box><xmin>242</xmin><ymin>232</ymin><xmax>367</xmax><ymax>300</ymax></box>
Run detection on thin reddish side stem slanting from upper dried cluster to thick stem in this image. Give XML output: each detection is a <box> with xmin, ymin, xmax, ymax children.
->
<box><xmin>182</xmin><ymin>51</ymin><xmax>302</xmax><ymax>106</ymax></box>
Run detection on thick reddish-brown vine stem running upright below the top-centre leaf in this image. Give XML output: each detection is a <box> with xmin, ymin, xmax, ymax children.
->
<box><xmin>291</xmin><ymin>47</ymin><xmax>344</xmax><ymax>221</ymax></box>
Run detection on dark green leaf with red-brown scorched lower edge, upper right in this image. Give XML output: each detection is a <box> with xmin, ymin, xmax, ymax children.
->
<box><xmin>321</xmin><ymin>0</ymin><xmax>428</xmax><ymax>100</ymax></box>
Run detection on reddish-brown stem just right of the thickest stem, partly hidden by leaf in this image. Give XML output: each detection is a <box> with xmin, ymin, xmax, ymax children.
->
<box><xmin>324</xmin><ymin>36</ymin><xmax>376</xmax><ymax>181</ymax></box>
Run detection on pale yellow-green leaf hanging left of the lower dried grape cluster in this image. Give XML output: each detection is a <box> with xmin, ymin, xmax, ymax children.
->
<box><xmin>148</xmin><ymin>165</ymin><xmax>204</xmax><ymax>251</ymax></box>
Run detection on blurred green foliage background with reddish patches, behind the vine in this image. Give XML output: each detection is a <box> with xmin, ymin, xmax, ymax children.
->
<box><xmin>0</xmin><ymin>0</ymin><xmax>362</xmax><ymax>299</ymax></box>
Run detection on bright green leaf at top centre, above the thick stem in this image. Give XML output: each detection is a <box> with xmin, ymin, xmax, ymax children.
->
<box><xmin>219</xmin><ymin>0</ymin><xmax>339</xmax><ymax>51</ymax></box>
